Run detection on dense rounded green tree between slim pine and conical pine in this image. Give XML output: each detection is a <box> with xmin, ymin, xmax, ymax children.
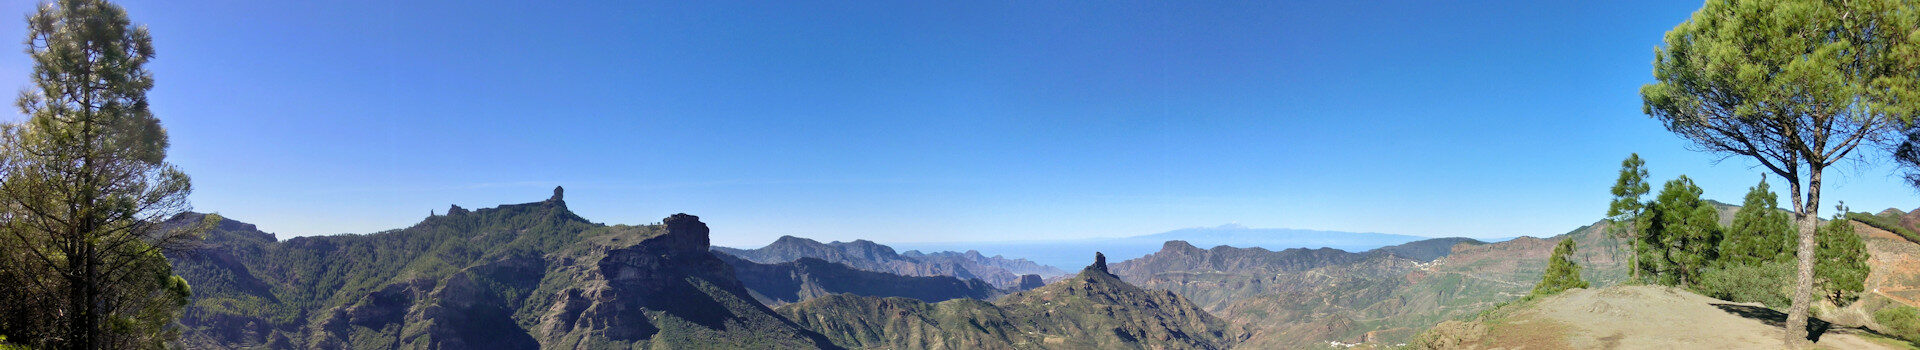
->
<box><xmin>1636</xmin><ymin>175</ymin><xmax>1720</xmax><ymax>287</ymax></box>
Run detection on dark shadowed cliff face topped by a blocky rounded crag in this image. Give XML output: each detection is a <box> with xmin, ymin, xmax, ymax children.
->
<box><xmin>538</xmin><ymin>213</ymin><xmax>833</xmax><ymax>348</ymax></box>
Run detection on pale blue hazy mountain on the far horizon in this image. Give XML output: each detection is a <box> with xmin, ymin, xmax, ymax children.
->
<box><xmin>891</xmin><ymin>225</ymin><xmax>1428</xmax><ymax>265</ymax></box>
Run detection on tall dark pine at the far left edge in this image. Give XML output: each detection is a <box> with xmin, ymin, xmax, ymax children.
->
<box><xmin>0</xmin><ymin>0</ymin><xmax>213</xmax><ymax>348</ymax></box>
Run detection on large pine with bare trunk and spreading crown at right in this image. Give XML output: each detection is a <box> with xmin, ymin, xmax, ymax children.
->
<box><xmin>1640</xmin><ymin>0</ymin><xmax>1920</xmax><ymax>342</ymax></box>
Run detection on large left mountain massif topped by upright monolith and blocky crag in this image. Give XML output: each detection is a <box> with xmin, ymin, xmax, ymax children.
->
<box><xmin>171</xmin><ymin>188</ymin><xmax>837</xmax><ymax>348</ymax></box>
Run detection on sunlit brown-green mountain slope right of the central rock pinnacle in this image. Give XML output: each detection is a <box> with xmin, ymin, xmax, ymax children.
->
<box><xmin>1114</xmin><ymin>227</ymin><xmax>1626</xmax><ymax>348</ymax></box>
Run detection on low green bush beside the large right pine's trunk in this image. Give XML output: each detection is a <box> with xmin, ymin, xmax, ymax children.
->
<box><xmin>1693</xmin><ymin>260</ymin><xmax>1793</xmax><ymax>310</ymax></box>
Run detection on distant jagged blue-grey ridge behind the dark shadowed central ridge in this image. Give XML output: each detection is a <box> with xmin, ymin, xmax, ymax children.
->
<box><xmin>714</xmin><ymin>237</ymin><xmax>1066</xmax><ymax>288</ymax></box>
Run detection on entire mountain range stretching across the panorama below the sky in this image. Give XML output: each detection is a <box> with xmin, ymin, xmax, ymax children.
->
<box><xmin>167</xmin><ymin>188</ymin><xmax>1920</xmax><ymax>348</ymax></box>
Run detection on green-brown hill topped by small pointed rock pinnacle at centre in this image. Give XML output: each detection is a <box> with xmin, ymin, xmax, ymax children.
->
<box><xmin>780</xmin><ymin>258</ymin><xmax>1242</xmax><ymax>348</ymax></box>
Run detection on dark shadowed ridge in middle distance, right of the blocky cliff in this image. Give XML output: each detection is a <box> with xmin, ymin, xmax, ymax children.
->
<box><xmin>714</xmin><ymin>252</ymin><xmax>1000</xmax><ymax>306</ymax></box>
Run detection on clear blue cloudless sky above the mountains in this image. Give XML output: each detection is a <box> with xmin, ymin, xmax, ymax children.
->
<box><xmin>0</xmin><ymin>0</ymin><xmax>1920</xmax><ymax>246</ymax></box>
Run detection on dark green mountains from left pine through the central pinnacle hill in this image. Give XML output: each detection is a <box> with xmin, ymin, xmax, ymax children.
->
<box><xmin>167</xmin><ymin>188</ymin><xmax>1242</xmax><ymax>348</ymax></box>
